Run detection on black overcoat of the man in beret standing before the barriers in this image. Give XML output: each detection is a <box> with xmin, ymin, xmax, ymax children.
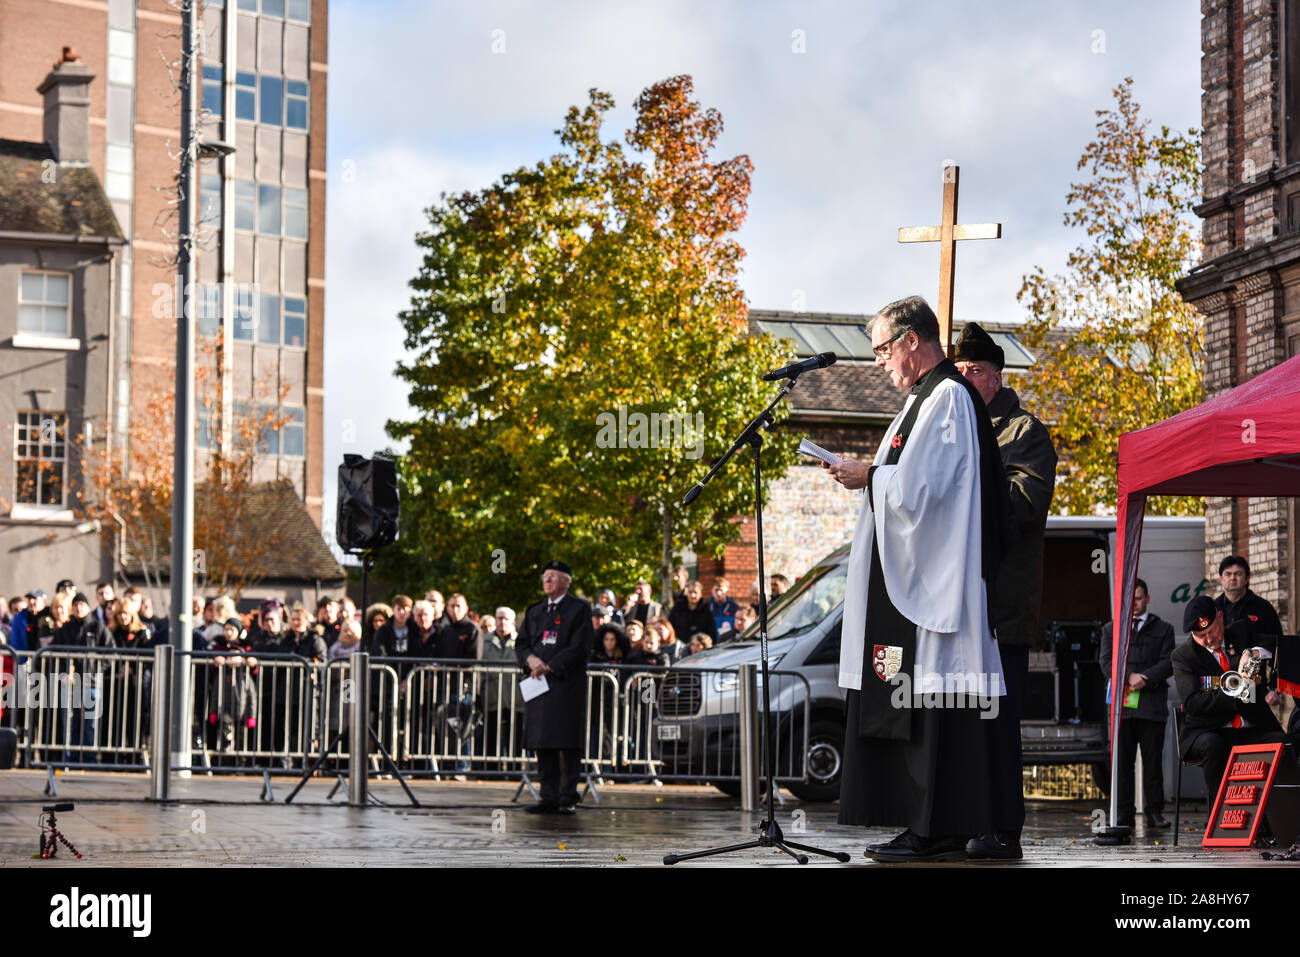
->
<box><xmin>515</xmin><ymin>594</ymin><xmax>593</xmax><ymax>750</ymax></box>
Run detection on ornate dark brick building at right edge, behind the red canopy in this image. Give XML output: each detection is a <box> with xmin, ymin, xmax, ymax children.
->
<box><xmin>1179</xmin><ymin>0</ymin><xmax>1300</xmax><ymax>632</ymax></box>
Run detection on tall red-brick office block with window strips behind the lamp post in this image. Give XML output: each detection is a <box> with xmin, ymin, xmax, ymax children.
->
<box><xmin>0</xmin><ymin>0</ymin><xmax>329</xmax><ymax>527</ymax></box>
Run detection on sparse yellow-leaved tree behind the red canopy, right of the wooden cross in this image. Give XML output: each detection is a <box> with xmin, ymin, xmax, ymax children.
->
<box><xmin>1018</xmin><ymin>77</ymin><xmax>1204</xmax><ymax>515</ymax></box>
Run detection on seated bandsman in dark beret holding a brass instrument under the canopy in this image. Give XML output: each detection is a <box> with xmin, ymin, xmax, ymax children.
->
<box><xmin>1171</xmin><ymin>596</ymin><xmax>1284</xmax><ymax>796</ymax></box>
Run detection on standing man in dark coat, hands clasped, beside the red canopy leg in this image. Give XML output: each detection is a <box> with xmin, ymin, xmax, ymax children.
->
<box><xmin>1100</xmin><ymin>579</ymin><xmax>1174</xmax><ymax>827</ymax></box>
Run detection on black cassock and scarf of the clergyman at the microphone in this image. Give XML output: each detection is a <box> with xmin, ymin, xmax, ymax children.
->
<box><xmin>839</xmin><ymin>359</ymin><xmax>1009</xmax><ymax>837</ymax></box>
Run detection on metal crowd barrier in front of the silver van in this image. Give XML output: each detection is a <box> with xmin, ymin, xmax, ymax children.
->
<box><xmin>606</xmin><ymin>668</ymin><xmax>811</xmax><ymax>788</ymax></box>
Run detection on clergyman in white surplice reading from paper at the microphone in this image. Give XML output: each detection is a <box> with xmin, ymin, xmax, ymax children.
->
<box><xmin>827</xmin><ymin>296</ymin><xmax>1008</xmax><ymax>862</ymax></box>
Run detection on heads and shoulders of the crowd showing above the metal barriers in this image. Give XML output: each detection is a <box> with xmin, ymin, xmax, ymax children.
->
<box><xmin>0</xmin><ymin>567</ymin><xmax>789</xmax><ymax>664</ymax></box>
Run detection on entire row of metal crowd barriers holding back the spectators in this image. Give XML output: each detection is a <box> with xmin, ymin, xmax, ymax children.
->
<box><xmin>10</xmin><ymin>646</ymin><xmax>811</xmax><ymax>793</ymax></box>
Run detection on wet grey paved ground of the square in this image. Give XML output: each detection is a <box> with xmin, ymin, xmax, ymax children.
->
<box><xmin>0</xmin><ymin>771</ymin><xmax>1277</xmax><ymax>867</ymax></box>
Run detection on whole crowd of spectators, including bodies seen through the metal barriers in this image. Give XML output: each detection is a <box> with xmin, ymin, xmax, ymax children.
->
<box><xmin>0</xmin><ymin>567</ymin><xmax>789</xmax><ymax>770</ymax></box>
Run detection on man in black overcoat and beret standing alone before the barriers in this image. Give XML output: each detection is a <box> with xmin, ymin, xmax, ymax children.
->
<box><xmin>515</xmin><ymin>562</ymin><xmax>594</xmax><ymax>814</ymax></box>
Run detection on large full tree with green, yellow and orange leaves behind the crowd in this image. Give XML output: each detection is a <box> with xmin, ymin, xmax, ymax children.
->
<box><xmin>380</xmin><ymin>77</ymin><xmax>794</xmax><ymax>603</ymax></box>
